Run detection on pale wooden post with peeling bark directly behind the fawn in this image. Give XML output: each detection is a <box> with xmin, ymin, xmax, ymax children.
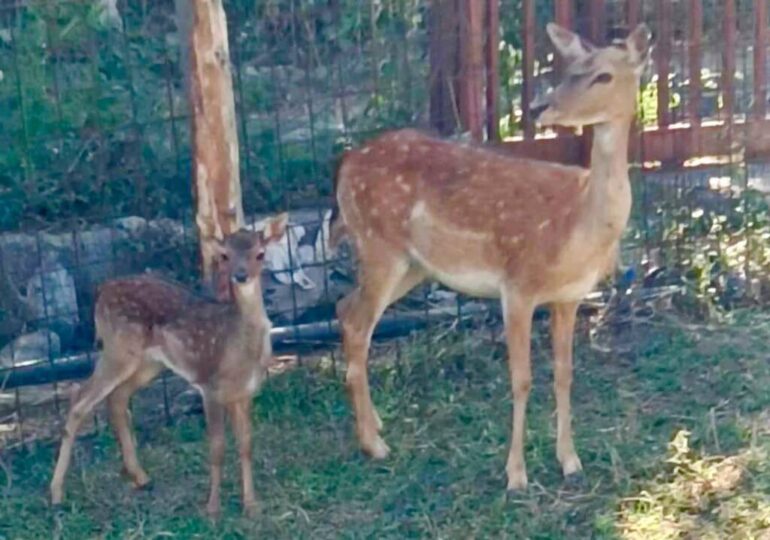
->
<box><xmin>181</xmin><ymin>0</ymin><xmax>243</xmax><ymax>280</ymax></box>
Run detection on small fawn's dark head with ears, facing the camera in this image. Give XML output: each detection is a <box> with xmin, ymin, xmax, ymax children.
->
<box><xmin>214</xmin><ymin>213</ymin><xmax>289</xmax><ymax>301</ymax></box>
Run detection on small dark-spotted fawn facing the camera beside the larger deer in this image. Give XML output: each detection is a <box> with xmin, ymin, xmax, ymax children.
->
<box><xmin>51</xmin><ymin>214</ymin><xmax>288</xmax><ymax>516</ymax></box>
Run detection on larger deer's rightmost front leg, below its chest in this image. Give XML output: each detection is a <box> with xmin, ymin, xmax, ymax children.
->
<box><xmin>551</xmin><ymin>302</ymin><xmax>582</xmax><ymax>476</ymax></box>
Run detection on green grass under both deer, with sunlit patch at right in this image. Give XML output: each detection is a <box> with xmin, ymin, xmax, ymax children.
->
<box><xmin>0</xmin><ymin>311</ymin><xmax>770</xmax><ymax>540</ymax></box>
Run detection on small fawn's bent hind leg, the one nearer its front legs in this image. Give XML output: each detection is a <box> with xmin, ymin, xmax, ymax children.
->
<box><xmin>107</xmin><ymin>362</ymin><xmax>162</xmax><ymax>489</ymax></box>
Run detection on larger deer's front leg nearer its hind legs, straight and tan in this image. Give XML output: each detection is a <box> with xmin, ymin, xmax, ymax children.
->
<box><xmin>503</xmin><ymin>291</ymin><xmax>534</xmax><ymax>490</ymax></box>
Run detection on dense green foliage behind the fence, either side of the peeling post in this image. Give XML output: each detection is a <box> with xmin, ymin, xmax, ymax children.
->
<box><xmin>0</xmin><ymin>0</ymin><xmax>427</xmax><ymax>230</ymax></box>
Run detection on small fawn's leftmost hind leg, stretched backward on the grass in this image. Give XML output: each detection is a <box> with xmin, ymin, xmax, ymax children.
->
<box><xmin>51</xmin><ymin>349</ymin><xmax>136</xmax><ymax>505</ymax></box>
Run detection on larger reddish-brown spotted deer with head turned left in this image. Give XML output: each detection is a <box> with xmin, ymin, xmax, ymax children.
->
<box><xmin>332</xmin><ymin>24</ymin><xmax>650</xmax><ymax>489</ymax></box>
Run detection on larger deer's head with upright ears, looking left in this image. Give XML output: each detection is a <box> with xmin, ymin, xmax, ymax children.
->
<box><xmin>531</xmin><ymin>23</ymin><xmax>651</xmax><ymax>127</ymax></box>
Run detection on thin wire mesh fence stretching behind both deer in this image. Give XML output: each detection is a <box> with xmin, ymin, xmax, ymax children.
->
<box><xmin>0</xmin><ymin>0</ymin><xmax>770</xmax><ymax>445</ymax></box>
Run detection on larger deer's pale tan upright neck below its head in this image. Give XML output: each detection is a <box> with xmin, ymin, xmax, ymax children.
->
<box><xmin>589</xmin><ymin>118</ymin><xmax>632</xmax><ymax>230</ymax></box>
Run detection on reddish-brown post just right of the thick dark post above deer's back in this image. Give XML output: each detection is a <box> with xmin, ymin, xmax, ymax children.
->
<box><xmin>459</xmin><ymin>0</ymin><xmax>484</xmax><ymax>141</ymax></box>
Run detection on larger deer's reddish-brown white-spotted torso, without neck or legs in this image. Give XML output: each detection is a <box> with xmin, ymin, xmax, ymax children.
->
<box><xmin>337</xmin><ymin>130</ymin><xmax>589</xmax><ymax>296</ymax></box>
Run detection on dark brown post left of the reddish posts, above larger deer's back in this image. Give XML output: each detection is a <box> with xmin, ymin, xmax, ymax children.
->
<box><xmin>428</xmin><ymin>0</ymin><xmax>460</xmax><ymax>135</ymax></box>
